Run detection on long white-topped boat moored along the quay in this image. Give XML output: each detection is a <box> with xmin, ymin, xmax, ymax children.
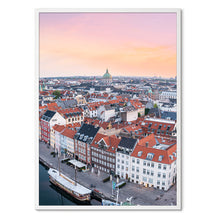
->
<box><xmin>48</xmin><ymin>168</ymin><xmax>92</xmax><ymax>201</ymax></box>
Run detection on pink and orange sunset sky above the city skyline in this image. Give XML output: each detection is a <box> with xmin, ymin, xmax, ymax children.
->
<box><xmin>39</xmin><ymin>13</ymin><xmax>176</xmax><ymax>77</ymax></box>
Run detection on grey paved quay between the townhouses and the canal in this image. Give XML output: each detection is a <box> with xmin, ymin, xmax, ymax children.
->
<box><xmin>39</xmin><ymin>141</ymin><xmax>176</xmax><ymax>206</ymax></box>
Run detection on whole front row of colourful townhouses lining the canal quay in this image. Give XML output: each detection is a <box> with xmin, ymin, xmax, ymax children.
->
<box><xmin>42</xmin><ymin>112</ymin><xmax>177</xmax><ymax>190</ymax></box>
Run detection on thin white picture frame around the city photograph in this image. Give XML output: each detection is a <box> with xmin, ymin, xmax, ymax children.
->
<box><xmin>35</xmin><ymin>8</ymin><xmax>182</xmax><ymax>211</ymax></box>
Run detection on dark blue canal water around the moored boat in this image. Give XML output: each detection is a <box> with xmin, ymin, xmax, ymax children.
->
<box><xmin>39</xmin><ymin>163</ymin><xmax>101</xmax><ymax>206</ymax></box>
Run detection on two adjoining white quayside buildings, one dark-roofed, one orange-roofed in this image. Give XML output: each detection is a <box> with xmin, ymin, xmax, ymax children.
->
<box><xmin>116</xmin><ymin>134</ymin><xmax>177</xmax><ymax>190</ymax></box>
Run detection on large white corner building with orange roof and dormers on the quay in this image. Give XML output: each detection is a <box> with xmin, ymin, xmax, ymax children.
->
<box><xmin>129</xmin><ymin>134</ymin><xmax>177</xmax><ymax>191</ymax></box>
